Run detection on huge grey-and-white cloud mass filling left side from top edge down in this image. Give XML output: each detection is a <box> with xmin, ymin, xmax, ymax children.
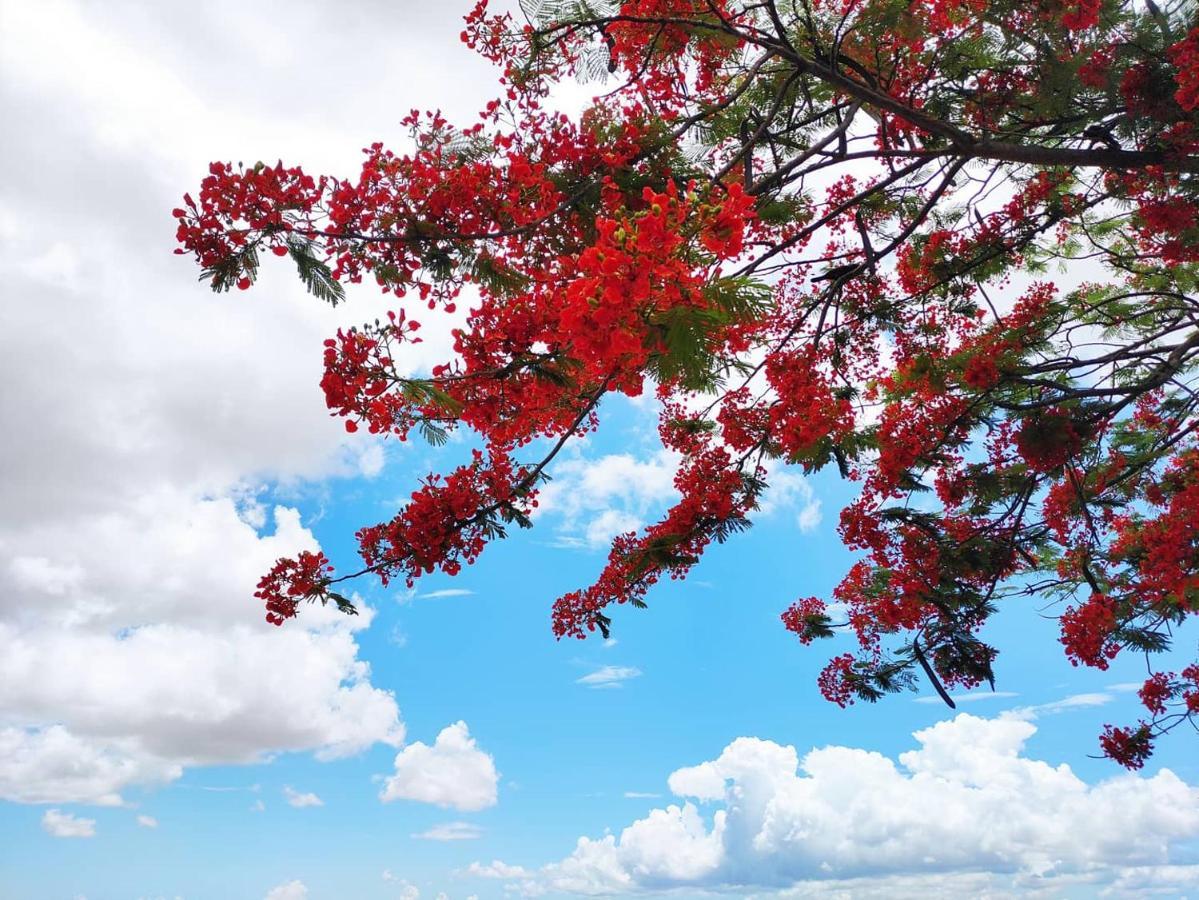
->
<box><xmin>0</xmin><ymin>0</ymin><xmax>501</xmax><ymax>804</ymax></box>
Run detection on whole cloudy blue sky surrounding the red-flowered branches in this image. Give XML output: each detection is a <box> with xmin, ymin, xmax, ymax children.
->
<box><xmin>0</xmin><ymin>0</ymin><xmax>1199</xmax><ymax>900</ymax></box>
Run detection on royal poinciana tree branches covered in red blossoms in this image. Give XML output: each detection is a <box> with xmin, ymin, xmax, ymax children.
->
<box><xmin>175</xmin><ymin>0</ymin><xmax>1199</xmax><ymax>767</ymax></box>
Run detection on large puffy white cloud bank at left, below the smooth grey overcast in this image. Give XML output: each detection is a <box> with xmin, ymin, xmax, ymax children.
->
<box><xmin>0</xmin><ymin>500</ymin><xmax>403</xmax><ymax>804</ymax></box>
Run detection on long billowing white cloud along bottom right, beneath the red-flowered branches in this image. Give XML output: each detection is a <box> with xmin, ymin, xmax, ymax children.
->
<box><xmin>474</xmin><ymin>714</ymin><xmax>1199</xmax><ymax>896</ymax></box>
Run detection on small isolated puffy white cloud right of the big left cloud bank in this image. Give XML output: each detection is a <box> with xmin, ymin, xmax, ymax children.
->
<box><xmin>379</xmin><ymin>721</ymin><xmax>499</xmax><ymax>813</ymax></box>
